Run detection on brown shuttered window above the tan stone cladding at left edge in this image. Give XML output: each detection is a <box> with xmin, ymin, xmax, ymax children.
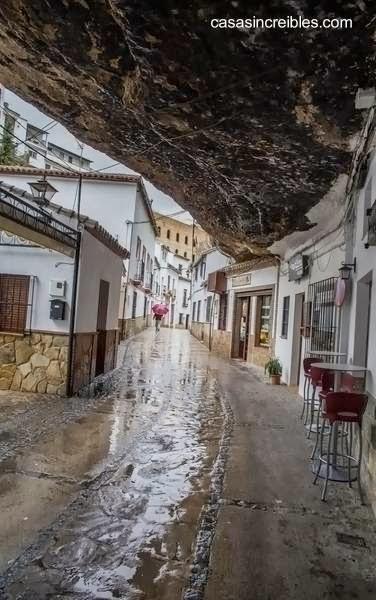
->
<box><xmin>0</xmin><ymin>274</ymin><xmax>31</xmax><ymax>333</ymax></box>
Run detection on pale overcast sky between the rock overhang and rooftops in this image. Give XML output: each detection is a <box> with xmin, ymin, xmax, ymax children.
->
<box><xmin>4</xmin><ymin>90</ymin><xmax>192</xmax><ymax>223</ymax></box>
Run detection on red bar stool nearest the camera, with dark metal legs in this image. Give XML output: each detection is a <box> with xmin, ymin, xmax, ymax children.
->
<box><xmin>314</xmin><ymin>392</ymin><xmax>368</xmax><ymax>504</ymax></box>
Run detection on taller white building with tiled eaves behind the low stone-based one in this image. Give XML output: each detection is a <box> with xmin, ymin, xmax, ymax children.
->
<box><xmin>0</xmin><ymin>165</ymin><xmax>158</xmax><ymax>337</ymax></box>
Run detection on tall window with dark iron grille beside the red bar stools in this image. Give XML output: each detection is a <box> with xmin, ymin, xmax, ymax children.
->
<box><xmin>304</xmin><ymin>277</ymin><xmax>339</xmax><ymax>352</ymax></box>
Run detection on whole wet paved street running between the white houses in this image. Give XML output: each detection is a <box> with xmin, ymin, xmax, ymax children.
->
<box><xmin>0</xmin><ymin>329</ymin><xmax>376</xmax><ymax>600</ymax></box>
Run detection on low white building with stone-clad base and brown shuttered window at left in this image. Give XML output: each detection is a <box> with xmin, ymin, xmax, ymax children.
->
<box><xmin>0</xmin><ymin>182</ymin><xmax>128</xmax><ymax>394</ymax></box>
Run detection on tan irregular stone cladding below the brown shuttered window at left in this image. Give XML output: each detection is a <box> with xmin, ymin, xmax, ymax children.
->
<box><xmin>0</xmin><ymin>333</ymin><xmax>69</xmax><ymax>395</ymax></box>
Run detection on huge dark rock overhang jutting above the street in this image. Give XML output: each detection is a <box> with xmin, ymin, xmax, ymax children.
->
<box><xmin>0</xmin><ymin>0</ymin><xmax>375</xmax><ymax>257</ymax></box>
